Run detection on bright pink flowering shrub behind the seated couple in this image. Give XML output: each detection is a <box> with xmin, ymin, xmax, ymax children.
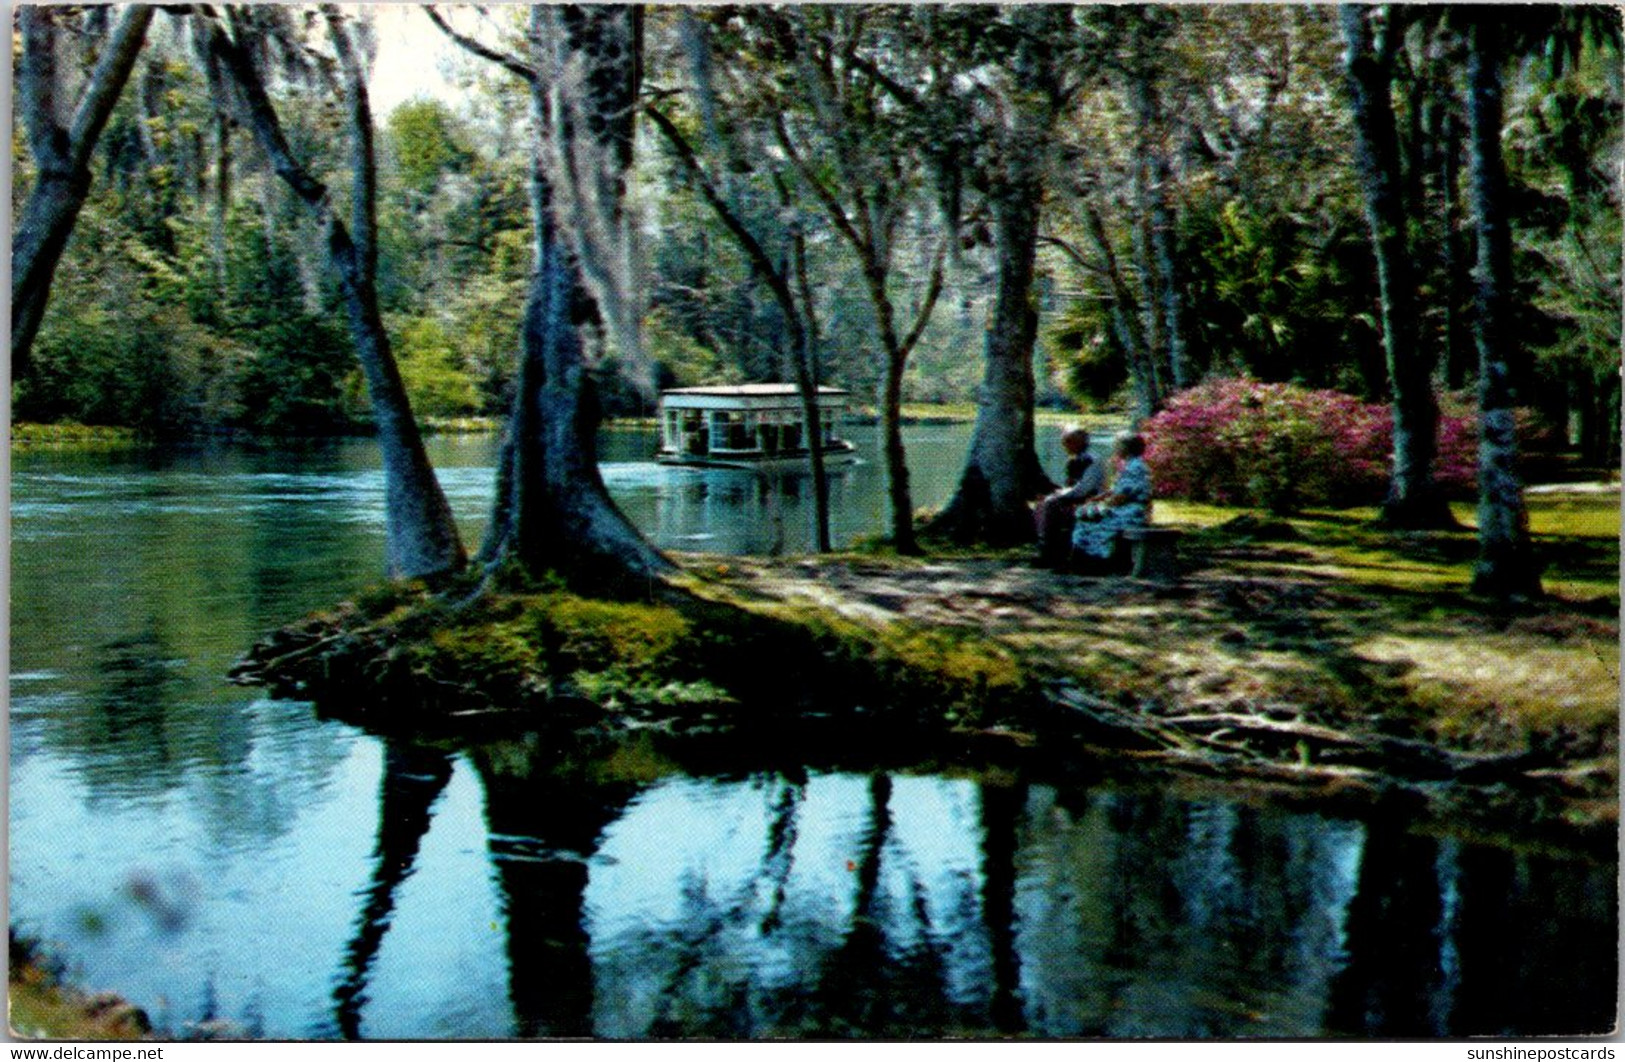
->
<box><xmin>1141</xmin><ymin>380</ymin><xmax>1477</xmax><ymax>512</ymax></box>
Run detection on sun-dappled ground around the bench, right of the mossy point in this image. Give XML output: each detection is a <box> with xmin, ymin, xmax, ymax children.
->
<box><xmin>692</xmin><ymin>492</ymin><xmax>1619</xmax><ymax>850</ymax></box>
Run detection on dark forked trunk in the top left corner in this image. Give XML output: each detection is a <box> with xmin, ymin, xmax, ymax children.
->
<box><xmin>11</xmin><ymin>3</ymin><xmax>154</xmax><ymax>380</ymax></box>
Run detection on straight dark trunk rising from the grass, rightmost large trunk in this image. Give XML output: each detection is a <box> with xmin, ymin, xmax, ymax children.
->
<box><xmin>1467</xmin><ymin>15</ymin><xmax>1541</xmax><ymax>598</ymax></box>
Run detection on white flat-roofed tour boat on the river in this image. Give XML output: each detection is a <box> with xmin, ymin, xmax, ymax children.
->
<box><xmin>655</xmin><ymin>383</ymin><xmax>858</xmax><ymax>468</ymax></box>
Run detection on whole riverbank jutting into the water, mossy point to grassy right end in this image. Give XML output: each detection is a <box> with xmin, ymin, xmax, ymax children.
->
<box><xmin>241</xmin><ymin>490</ymin><xmax>1619</xmax><ymax>844</ymax></box>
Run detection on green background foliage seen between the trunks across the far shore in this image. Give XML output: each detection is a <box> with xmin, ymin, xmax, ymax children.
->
<box><xmin>13</xmin><ymin>5</ymin><xmax>1622</xmax><ymax>460</ymax></box>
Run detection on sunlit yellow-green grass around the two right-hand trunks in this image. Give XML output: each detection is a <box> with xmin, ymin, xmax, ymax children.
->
<box><xmin>1159</xmin><ymin>492</ymin><xmax>1620</xmax><ymax>756</ymax></box>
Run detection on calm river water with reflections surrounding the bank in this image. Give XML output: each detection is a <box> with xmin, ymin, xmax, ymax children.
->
<box><xmin>10</xmin><ymin>427</ymin><xmax>1617</xmax><ymax>1038</ymax></box>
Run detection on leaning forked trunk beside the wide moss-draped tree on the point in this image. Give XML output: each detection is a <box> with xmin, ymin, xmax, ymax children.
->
<box><xmin>210</xmin><ymin>15</ymin><xmax>465</xmax><ymax>578</ymax></box>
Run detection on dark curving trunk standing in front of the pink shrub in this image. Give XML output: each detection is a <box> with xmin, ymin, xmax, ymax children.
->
<box><xmin>1341</xmin><ymin>5</ymin><xmax>1456</xmax><ymax>528</ymax></box>
